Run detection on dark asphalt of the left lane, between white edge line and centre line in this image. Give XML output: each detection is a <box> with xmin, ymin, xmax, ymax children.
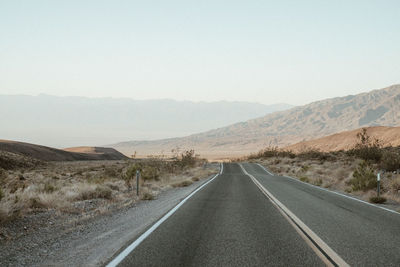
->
<box><xmin>119</xmin><ymin>164</ymin><xmax>324</xmax><ymax>266</ymax></box>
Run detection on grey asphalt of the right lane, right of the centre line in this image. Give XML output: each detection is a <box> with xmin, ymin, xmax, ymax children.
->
<box><xmin>243</xmin><ymin>163</ymin><xmax>400</xmax><ymax>266</ymax></box>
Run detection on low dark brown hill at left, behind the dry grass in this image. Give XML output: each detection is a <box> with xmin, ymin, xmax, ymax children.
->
<box><xmin>0</xmin><ymin>140</ymin><xmax>127</xmax><ymax>161</ymax></box>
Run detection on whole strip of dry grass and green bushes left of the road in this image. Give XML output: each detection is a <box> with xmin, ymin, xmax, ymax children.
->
<box><xmin>0</xmin><ymin>150</ymin><xmax>218</xmax><ymax>223</ymax></box>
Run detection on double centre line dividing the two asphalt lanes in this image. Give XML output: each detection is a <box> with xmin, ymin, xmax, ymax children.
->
<box><xmin>239</xmin><ymin>164</ymin><xmax>350</xmax><ymax>266</ymax></box>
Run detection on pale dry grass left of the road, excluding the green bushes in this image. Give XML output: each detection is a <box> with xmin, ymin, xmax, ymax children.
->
<box><xmin>0</xmin><ymin>159</ymin><xmax>218</xmax><ymax>222</ymax></box>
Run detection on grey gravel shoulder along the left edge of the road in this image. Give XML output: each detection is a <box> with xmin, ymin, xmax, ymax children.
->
<box><xmin>0</xmin><ymin>166</ymin><xmax>219</xmax><ymax>266</ymax></box>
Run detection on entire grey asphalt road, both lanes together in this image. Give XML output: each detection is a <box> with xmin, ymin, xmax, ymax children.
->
<box><xmin>108</xmin><ymin>163</ymin><xmax>400</xmax><ymax>266</ymax></box>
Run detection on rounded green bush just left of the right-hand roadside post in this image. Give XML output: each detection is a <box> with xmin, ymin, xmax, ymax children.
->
<box><xmin>348</xmin><ymin>161</ymin><xmax>377</xmax><ymax>191</ymax></box>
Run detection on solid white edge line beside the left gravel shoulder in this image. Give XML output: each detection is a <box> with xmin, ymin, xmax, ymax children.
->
<box><xmin>106</xmin><ymin>163</ymin><xmax>224</xmax><ymax>267</ymax></box>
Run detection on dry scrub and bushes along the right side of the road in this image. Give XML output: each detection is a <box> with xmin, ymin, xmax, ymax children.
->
<box><xmin>246</xmin><ymin>129</ymin><xmax>400</xmax><ymax>206</ymax></box>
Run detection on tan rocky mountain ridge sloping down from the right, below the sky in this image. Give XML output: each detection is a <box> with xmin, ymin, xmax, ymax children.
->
<box><xmin>112</xmin><ymin>85</ymin><xmax>400</xmax><ymax>158</ymax></box>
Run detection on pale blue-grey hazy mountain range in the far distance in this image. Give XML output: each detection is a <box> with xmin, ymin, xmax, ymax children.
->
<box><xmin>0</xmin><ymin>95</ymin><xmax>291</xmax><ymax>148</ymax></box>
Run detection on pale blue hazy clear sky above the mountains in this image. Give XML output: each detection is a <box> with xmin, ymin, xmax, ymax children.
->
<box><xmin>0</xmin><ymin>0</ymin><xmax>400</xmax><ymax>105</ymax></box>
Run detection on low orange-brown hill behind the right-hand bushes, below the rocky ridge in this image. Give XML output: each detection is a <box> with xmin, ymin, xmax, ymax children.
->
<box><xmin>285</xmin><ymin>126</ymin><xmax>400</xmax><ymax>152</ymax></box>
